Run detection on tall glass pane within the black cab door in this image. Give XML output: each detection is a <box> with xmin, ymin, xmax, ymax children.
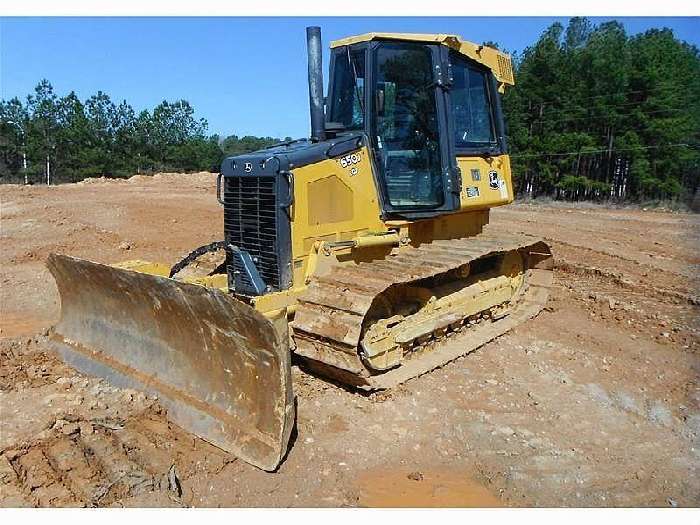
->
<box><xmin>374</xmin><ymin>43</ymin><xmax>444</xmax><ymax>208</ymax></box>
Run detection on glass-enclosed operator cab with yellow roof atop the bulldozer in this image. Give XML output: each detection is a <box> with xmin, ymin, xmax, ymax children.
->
<box><xmin>326</xmin><ymin>33</ymin><xmax>512</xmax><ymax>218</ymax></box>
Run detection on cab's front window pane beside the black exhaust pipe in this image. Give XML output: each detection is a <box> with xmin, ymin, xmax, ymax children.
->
<box><xmin>330</xmin><ymin>47</ymin><xmax>365</xmax><ymax>130</ymax></box>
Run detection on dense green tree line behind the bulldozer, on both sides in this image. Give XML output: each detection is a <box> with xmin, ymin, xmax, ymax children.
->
<box><xmin>0</xmin><ymin>17</ymin><xmax>700</xmax><ymax>202</ymax></box>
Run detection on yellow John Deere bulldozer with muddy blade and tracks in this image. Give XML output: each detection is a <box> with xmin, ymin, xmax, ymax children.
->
<box><xmin>47</xmin><ymin>27</ymin><xmax>552</xmax><ymax>470</ymax></box>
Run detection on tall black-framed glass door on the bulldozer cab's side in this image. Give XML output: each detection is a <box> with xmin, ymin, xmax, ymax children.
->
<box><xmin>369</xmin><ymin>41</ymin><xmax>459</xmax><ymax>218</ymax></box>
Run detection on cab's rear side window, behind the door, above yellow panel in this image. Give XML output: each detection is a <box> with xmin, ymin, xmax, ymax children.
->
<box><xmin>450</xmin><ymin>58</ymin><xmax>496</xmax><ymax>148</ymax></box>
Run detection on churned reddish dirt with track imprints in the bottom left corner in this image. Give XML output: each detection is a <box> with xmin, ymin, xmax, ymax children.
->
<box><xmin>0</xmin><ymin>406</ymin><xmax>235</xmax><ymax>507</ymax></box>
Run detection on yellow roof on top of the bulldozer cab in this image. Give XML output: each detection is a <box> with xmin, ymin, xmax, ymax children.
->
<box><xmin>331</xmin><ymin>33</ymin><xmax>515</xmax><ymax>86</ymax></box>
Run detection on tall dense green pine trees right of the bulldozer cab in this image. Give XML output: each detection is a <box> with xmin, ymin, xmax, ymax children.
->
<box><xmin>503</xmin><ymin>17</ymin><xmax>700</xmax><ymax>201</ymax></box>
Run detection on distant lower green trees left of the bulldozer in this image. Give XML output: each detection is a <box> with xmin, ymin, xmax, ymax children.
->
<box><xmin>0</xmin><ymin>80</ymin><xmax>291</xmax><ymax>183</ymax></box>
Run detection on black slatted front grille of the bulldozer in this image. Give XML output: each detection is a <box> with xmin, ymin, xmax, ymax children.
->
<box><xmin>224</xmin><ymin>177</ymin><xmax>280</xmax><ymax>290</ymax></box>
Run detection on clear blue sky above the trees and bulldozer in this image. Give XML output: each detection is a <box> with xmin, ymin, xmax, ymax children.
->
<box><xmin>0</xmin><ymin>17</ymin><xmax>700</xmax><ymax>137</ymax></box>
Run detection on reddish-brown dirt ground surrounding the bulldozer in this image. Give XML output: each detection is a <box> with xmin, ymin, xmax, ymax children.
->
<box><xmin>0</xmin><ymin>174</ymin><xmax>700</xmax><ymax>507</ymax></box>
